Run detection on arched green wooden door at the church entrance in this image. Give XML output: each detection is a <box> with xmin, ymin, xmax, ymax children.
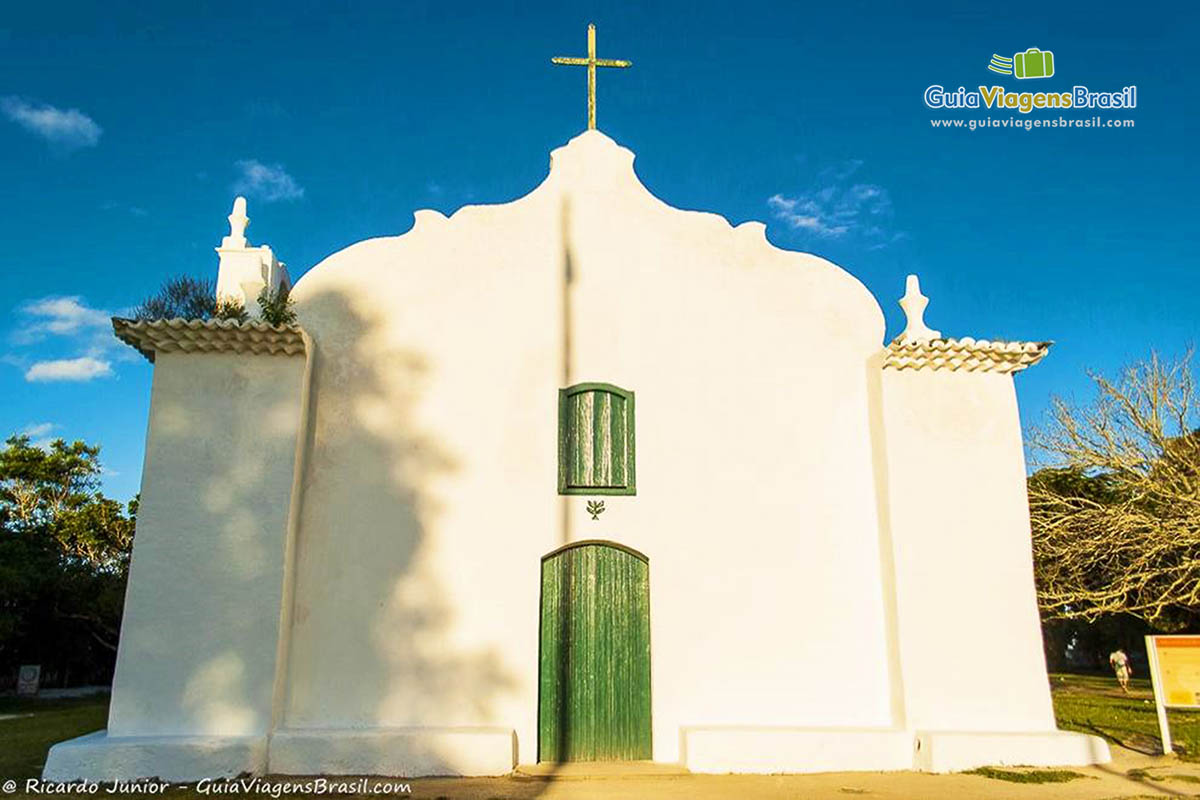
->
<box><xmin>538</xmin><ymin>541</ymin><xmax>652</xmax><ymax>762</ymax></box>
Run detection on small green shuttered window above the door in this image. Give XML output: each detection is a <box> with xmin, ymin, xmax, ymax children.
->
<box><xmin>558</xmin><ymin>384</ymin><xmax>637</xmax><ymax>494</ymax></box>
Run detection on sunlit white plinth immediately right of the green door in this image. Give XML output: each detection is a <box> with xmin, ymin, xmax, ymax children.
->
<box><xmin>679</xmin><ymin>727</ymin><xmax>912</xmax><ymax>774</ymax></box>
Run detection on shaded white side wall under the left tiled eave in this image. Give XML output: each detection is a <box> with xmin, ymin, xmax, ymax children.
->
<box><xmin>108</xmin><ymin>353</ymin><xmax>304</xmax><ymax>738</ymax></box>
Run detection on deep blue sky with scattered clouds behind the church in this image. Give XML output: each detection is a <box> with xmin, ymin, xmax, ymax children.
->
<box><xmin>0</xmin><ymin>0</ymin><xmax>1200</xmax><ymax>498</ymax></box>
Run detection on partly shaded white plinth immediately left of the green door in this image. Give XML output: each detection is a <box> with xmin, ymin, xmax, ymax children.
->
<box><xmin>268</xmin><ymin>727</ymin><xmax>517</xmax><ymax>777</ymax></box>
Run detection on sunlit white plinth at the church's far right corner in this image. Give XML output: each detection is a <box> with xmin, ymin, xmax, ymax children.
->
<box><xmin>913</xmin><ymin>730</ymin><xmax>1112</xmax><ymax>772</ymax></box>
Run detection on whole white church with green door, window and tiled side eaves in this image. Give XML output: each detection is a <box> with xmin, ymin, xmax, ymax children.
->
<box><xmin>46</xmin><ymin>131</ymin><xmax>1108</xmax><ymax>780</ymax></box>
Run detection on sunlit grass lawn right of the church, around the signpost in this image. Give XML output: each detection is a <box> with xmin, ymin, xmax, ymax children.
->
<box><xmin>1050</xmin><ymin>674</ymin><xmax>1200</xmax><ymax>760</ymax></box>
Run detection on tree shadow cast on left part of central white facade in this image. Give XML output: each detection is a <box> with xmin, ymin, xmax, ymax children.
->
<box><xmin>282</xmin><ymin>291</ymin><xmax>530</xmax><ymax>775</ymax></box>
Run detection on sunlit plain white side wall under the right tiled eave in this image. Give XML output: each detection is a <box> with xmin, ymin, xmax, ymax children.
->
<box><xmin>883</xmin><ymin>369</ymin><xmax>1055</xmax><ymax>732</ymax></box>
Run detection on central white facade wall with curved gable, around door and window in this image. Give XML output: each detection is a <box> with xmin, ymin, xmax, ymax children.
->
<box><xmin>284</xmin><ymin>132</ymin><xmax>892</xmax><ymax>762</ymax></box>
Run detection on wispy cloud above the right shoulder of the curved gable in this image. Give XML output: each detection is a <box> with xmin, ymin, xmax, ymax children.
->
<box><xmin>767</xmin><ymin>160</ymin><xmax>904</xmax><ymax>249</ymax></box>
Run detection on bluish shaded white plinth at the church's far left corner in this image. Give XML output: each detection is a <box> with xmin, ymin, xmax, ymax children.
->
<box><xmin>42</xmin><ymin>730</ymin><xmax>266</xmax><ymax>782</ymax></box>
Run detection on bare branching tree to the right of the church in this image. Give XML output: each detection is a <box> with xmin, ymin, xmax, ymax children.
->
<box><xmin>1030</xmin><ymin>351</ymin><xmax>1200</xmax><ymax>630</ymax></box>
